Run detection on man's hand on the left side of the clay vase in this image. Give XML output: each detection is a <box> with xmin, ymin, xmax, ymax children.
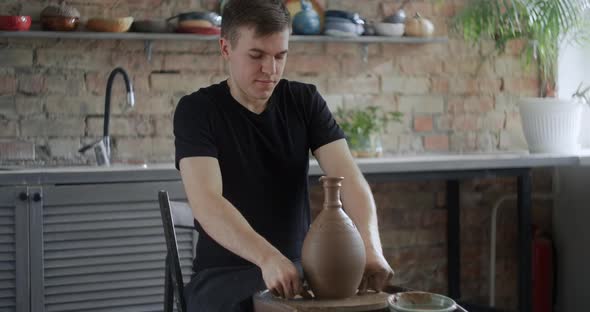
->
<box><xmin>260</xmin><ymin>254</ymin><xmax>303</xmax><ymax>299</ymax></box>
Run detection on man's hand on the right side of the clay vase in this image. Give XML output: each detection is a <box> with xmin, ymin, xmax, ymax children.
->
<box><xmin>359</xmin><ymin>253</ymin><xmax>393</xmax><ymax>294</ymax></box>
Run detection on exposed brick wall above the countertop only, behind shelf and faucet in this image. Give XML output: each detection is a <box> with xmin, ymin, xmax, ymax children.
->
<box><xmin>0</xmin><ymin>0</ymin><xmax>537</xmax><ymax>165</ymax></box>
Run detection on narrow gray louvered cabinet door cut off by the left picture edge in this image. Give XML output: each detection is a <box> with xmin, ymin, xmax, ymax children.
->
<box><xmin>0</xmin><ymin>186</ymin><xmax>30</xmax><ymax>312</ymax></box>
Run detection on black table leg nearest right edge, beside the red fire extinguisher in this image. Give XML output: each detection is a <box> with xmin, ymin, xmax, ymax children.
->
<box><xmin>517</xmin><ymin>170</ymin><xmax>532</xmax><ymax>312</ymax></box>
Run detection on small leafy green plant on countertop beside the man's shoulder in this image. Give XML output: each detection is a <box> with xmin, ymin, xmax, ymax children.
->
<box><xmin>334</xmin><ymin>106</ymin><xmax>403</xmax><ymax>149</ymax></box>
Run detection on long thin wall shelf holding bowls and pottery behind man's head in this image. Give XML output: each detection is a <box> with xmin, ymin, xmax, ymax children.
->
<box><xmin>0</xmin><ymin>31</ymin><xmax>448</xmax><ymax>44</ymax></box>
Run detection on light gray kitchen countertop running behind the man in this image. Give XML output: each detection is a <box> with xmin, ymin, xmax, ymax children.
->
<box><xmin>0</xmin><ymin>150</ymin><xmax>590</xmax><ymax>185</ymax></box>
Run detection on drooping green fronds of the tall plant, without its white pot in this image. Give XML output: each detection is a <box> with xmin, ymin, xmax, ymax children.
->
<box><xmin>454</xmin><ymin>0</ymin><xmax>590</xmax><ymax>96</ymax></box>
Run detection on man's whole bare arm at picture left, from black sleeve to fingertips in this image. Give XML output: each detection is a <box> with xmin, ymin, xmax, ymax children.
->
<box><xmin>180</xmin><ymin>157</ymin><xmax>301</xmax><ymax>297</ymax></box>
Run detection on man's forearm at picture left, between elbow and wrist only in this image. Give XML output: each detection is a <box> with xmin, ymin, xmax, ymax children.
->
<box><xmin>194</xmin><ymin>195</ymin><xmax>279</xmax><ymax>266</ymax></box>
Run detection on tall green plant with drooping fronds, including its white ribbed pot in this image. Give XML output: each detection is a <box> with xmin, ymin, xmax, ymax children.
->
<box><xmin>454</xmin><ymin>0</ymin><xmax>590</xmax><ymax>153</ymax></box>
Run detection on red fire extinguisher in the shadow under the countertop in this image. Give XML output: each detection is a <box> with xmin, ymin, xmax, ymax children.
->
<box><xmin>532</xmin><ymin>226</ymin><xmax>554</xmax><ymax>312</ymax></box>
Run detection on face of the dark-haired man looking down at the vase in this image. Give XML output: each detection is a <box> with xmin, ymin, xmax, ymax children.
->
<box><xmin>220</xmin><ymin>27</ymin><xmax>289</xmax><ymax>101</ymax></box>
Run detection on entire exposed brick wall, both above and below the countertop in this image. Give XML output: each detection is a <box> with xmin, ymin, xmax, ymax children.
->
<box><xmin>0</xmin><ymin>0</ymin><xmax>551</xmax><ymax>307</ymax></box>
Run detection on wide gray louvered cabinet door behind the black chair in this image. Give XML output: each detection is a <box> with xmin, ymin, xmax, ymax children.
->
<box><xmin>31</xmin><ymin>181</ymin><xmax>194</xmax><ymax>312</ymax></box>
